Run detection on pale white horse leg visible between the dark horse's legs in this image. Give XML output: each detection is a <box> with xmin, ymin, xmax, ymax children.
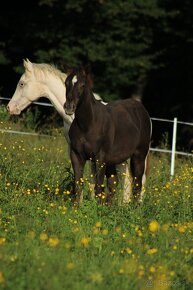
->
<box><xmin>117</xmin><ymin>161</ymin><xmax>132</xmax><ymax>203</ymax></box>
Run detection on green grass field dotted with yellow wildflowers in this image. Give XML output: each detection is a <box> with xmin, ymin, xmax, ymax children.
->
<box><xmin>0</xmin><ymin>122</ymin><xmax>193</xmax><ymax>290</ymax></box>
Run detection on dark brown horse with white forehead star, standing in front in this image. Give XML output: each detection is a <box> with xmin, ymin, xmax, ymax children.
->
<box><xmin>64</xmin><ymin>68</ymin><xmax>151</xmax><ymax>204</ymax></box>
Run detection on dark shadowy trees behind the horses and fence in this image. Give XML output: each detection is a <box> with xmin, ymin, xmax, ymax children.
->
<box><xmin>0</xmin><ymin>0</ymin><xmax>193</xmax><ymax>148</ymax></box>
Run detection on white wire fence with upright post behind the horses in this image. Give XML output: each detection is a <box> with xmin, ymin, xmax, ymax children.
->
<box><xmin>0</xmin><ymin>97</ymin><xmax>193</xmax><ymax>178</ymax></box>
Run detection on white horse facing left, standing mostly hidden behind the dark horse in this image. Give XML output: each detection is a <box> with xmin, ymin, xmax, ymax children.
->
<box><xmin>7</xmin><ymin>59</ymin><xmax>131</xmax><ymax>202</ymax></box>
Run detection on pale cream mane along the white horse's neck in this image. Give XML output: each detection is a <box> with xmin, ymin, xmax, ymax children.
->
<box><xmin>28</xmin><ymin>63</ymin><xmax>67</xmax><ymax>82</ymax></box>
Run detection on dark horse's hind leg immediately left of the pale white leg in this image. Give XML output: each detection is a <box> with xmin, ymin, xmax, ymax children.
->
<box><xmin>106</xmin><ymin>165</ymin><xmax>118</xmax><ymax>205</ymax></box>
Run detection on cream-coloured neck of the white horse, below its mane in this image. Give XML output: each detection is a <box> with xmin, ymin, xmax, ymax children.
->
<box><xmin>45</xmin><ymin>74</ymin><xmax>73</xmax><ymax>124</ymax></box>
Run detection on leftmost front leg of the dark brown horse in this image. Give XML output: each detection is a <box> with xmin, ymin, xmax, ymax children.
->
<box><xmin>70</xmin><ymin>150</ymin><xmax>86</xmax><ymax>205</ymax></box>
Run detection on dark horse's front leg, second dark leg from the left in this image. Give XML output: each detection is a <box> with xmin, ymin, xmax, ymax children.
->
<box><xmin>95</xmin><ymin>164</ymin><xmax>106</xmax><ymax>204</ymax></box>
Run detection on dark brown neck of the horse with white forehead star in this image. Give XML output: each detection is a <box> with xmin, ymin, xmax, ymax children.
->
<box><xmin>75</xmin><ymin>88</ymin><xmax>97</xmax><ymax>130</ymax></box>
